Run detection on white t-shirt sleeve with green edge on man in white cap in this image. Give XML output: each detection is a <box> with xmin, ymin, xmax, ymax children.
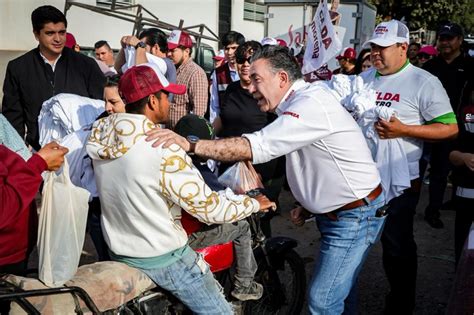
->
<box><xmin>419</xmin><ymin>76</ymin><xmax>456</xmax><ymax>123</ymax></box>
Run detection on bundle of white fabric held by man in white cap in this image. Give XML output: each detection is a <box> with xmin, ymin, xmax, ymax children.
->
<box><xmin>315</xmin><ymin>74</ymin><xmax>410</xmax><ymax>202</ymax></box>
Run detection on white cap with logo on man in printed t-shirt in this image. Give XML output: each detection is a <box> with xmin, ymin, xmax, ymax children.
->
<box><xmin>363</xmin><ymin>20</ymin><xmax>410</xmax><ymax>47</ymax></box>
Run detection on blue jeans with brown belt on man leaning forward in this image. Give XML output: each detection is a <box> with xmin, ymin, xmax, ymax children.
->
<box><xmin>308</xmin><ymin>194</ymin><xmax>385</xmax><ymax>315</ymax></box>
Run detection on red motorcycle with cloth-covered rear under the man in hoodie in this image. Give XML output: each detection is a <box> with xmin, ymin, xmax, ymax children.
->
<box><xmin>0</xmin><ymin>209</ymin><xmax>306</xmax><ymax>314</ymax></box>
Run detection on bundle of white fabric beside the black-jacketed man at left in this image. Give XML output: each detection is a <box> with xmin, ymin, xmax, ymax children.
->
<box><xmin>38</xmin><ymin>93</ymin><xmax>104</xmax><ymax>198</ymax></box>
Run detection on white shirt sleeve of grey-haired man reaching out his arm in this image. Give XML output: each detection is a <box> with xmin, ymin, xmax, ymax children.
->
<box><xmin>242</xmin><ymin>93</ymin><xmax>334</xmax><ymax>164</ymax></box>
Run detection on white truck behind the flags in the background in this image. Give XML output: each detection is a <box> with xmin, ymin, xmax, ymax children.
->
<box><xmin>265</xmin><ymin>0</ymin><xmax>377</xmax><ymax>69</ymax></box>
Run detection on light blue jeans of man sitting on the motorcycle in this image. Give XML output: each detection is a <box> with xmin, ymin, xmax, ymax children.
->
<box><xmin>141</xmin><ymin>250</ymin><xmax>233</xmax><ymax>314</ymax></box>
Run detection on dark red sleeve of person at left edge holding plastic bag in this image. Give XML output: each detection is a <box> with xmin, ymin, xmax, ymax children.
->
<box><xmin>0</xmin><ymin>146</ymin><xmax>47</xmax><ymax>229</ymax></box>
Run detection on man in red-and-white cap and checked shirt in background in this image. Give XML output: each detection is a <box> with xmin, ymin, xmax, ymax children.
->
<box><xmin>167</xmin><ymin>30</ymin><xmax>209</xmax><ymax>129</ymax></box>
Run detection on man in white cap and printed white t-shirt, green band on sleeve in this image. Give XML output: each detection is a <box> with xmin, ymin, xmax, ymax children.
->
<box><xmin>361</xmin><ymin>20</ymin><xmax>458</xmax><ymax>314</ymax></box>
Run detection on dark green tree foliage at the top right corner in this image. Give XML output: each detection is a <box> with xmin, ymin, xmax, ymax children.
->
<box><xmin>368</xmin><ymin>0</ymin><xmax>474</xmax><ymax>34</ymax></box>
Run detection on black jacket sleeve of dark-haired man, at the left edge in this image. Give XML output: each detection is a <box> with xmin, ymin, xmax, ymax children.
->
<box><xmin>2</xmin><ymin>63</ymin><xmax>26</xmax><ymax>138</ymax></box>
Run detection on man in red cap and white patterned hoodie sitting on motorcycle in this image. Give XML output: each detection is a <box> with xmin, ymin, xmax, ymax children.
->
<box><xmin>87</xmin><ymin>64</ymin><xmax>269</xmax><ymax>314</ymax></box>
